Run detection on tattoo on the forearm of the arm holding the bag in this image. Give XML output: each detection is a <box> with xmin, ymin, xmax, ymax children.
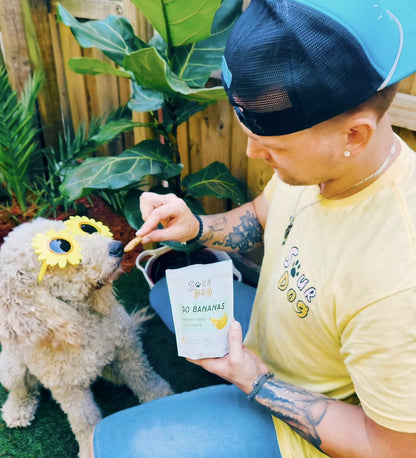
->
<box><xmin>255</xmin><ymin>378</ymin><xmax>337</xmax><ymax>453</ymax></box>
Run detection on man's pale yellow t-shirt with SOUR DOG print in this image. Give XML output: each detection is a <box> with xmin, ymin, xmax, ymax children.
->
<box><xmin>245</xmin><ymin>138</ymin><xmax>416</xmax><ymax>458</ymax></box>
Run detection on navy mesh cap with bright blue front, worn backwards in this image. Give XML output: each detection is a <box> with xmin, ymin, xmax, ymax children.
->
<box><xmin>222</xmin><ymin>0</ymin><xmax>416</xmax><ymax>136</ymax></box>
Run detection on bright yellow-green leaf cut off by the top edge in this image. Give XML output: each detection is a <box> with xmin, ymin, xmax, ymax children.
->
<box><xmin>132</xmin><ymin>0</ymin><xmax>221</xmax><ymax>46</ymax></box>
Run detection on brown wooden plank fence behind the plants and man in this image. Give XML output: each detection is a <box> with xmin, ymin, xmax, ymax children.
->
<box><xmin>0</xmin><ymin>0</ymin><xmax>416</xmax><ymax>216</ymax></box>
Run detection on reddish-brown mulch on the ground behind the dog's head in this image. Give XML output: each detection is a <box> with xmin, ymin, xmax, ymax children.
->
<box><xmin>0</xmin><ymin>198</ymin><xmax>142</xmax><ymax>272</ymax></box>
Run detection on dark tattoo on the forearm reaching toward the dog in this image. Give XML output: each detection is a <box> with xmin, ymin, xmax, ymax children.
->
<box><xmin>206</xmin><ymin>210</ymin><xmax>263</xmax><ymax>252</ymax></box>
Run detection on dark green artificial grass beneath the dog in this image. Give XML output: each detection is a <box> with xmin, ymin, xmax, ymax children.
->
<box><xmin>0</xmin><ymin>270</ymin><xmax>222</xmax><ymax>458</ymax></box>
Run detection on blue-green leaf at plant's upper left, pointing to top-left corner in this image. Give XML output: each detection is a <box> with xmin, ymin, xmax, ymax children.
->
<box><xmin>56</xmin><ymin>4</ymin><xmax>149</xmax><ymax>66</ymax></box>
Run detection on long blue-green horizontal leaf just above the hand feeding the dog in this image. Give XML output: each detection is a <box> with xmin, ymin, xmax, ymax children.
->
<box><xmin>59</xmin><ymin>140</ymin><xmax>183</xmax><ymax>200</ymax></box>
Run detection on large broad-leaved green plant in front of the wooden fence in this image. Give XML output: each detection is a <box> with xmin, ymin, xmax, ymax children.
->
<box><xmin>57</xmin><ymin>0</ymin><xmax>245</xmax><ymax>236</ymax></box>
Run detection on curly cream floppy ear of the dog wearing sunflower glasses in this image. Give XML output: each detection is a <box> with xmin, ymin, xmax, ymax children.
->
<box><xmin>0</xmin><ymin>271</ymin><xmax>80</xmax><ymax>347</ymax></box>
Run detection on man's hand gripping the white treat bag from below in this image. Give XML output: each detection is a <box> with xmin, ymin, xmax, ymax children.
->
<box><xmin>188</xmin><ymin>321</ymin><xmax>268</xmax><ymax>394</ymax></box>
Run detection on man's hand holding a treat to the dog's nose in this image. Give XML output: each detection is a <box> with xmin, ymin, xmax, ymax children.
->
<box><xmin>136</xmin><ymin>192</ymin><xmax>199</xmax><ymax>243</ymax></box>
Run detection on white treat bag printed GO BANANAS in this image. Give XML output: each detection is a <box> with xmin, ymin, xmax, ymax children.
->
<box><xmin>166</xmin><ymin>260</ymin><xmax>234</xmax><ymax>359</ymax></box>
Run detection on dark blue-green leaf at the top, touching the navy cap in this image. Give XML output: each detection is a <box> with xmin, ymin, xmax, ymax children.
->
<box><xmin>172</xmin><ymin>0</ymin><xmax>243</xmax><ymax>87</ymax></box>
